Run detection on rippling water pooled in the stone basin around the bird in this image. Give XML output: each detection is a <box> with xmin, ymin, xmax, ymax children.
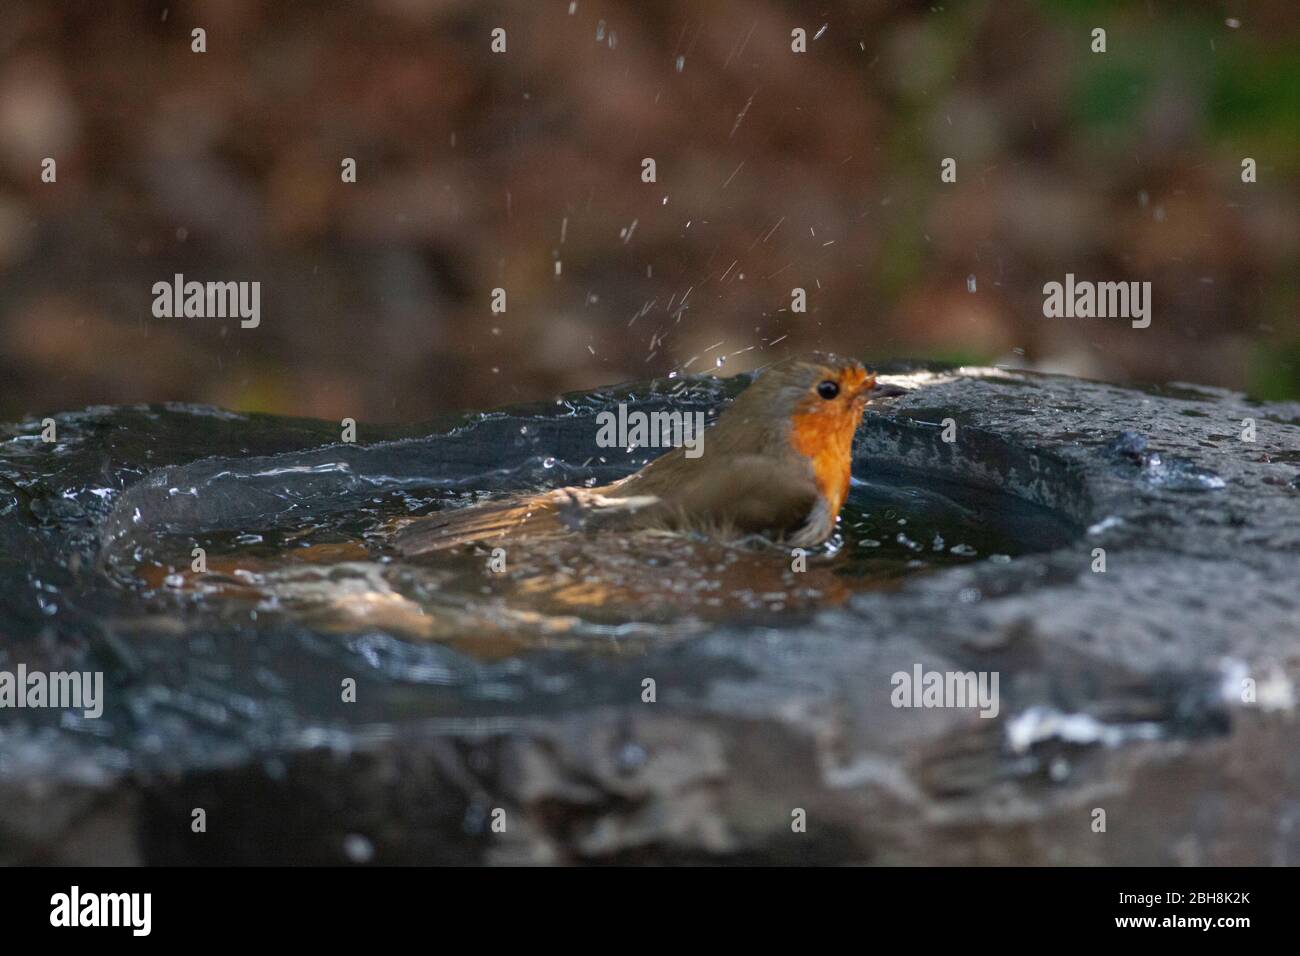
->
<box><xmin>116</xmin><ymin>452</ymin><xmax>1070</xmax><ymax>658</ymax></box>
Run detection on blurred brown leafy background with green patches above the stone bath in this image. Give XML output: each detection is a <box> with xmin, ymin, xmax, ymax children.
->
<box><xmin>0</xmin><ymin>0</ymin><xmax>1300</xmax><ymax>421</ymax></box>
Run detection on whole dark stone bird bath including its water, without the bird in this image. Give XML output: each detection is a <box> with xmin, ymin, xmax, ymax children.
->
<box><xmin>0</xmin><ymin>365</ymin><xmax>1300</xmax><ymax>864</ymax></box>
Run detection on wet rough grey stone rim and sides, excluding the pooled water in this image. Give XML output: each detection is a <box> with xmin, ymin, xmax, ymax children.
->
<box><xmin>0</xmin><ymin>367</ymin><xmax>1300</xmax><ymax>865</ymax></box>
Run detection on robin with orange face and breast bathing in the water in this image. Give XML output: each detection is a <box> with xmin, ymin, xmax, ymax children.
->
<box><xmin>394</xmin><ymin>352</ymin><xmax>904</xmax><ymax>555</ymax></box>
